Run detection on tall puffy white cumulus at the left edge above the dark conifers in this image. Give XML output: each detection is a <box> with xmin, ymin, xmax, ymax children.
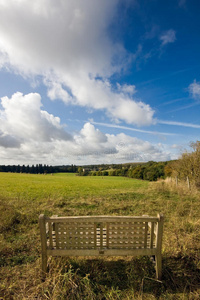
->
<box><xmin>0</xmin><ymin>92</ymin><xmax>72</xmax><ymax>147</ymax></box>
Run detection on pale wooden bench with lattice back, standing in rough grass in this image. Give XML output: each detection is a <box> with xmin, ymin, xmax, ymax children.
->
<box><xmin>39</xmin><ymin>214</ymin><xmax>163</xmax><ymax>280</ymax></box>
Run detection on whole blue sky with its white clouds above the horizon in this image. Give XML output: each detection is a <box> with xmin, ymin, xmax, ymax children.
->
<box><xmin>0</xmin><ymin>0</ymin><xmax>200</xmax><ymax>165</ymax></box>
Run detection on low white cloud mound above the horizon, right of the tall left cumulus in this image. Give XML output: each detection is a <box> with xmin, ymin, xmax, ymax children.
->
<box><xmin>48</xmin><ymin>127</ymin><xmax>170</xmax><ymax>164</ymax></box>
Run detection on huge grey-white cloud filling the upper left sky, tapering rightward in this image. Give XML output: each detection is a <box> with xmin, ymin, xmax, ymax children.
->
<box><xmin>0</xmin><ymin>0</ymin><xmax>155</xmax><ymax>126</ymax></box>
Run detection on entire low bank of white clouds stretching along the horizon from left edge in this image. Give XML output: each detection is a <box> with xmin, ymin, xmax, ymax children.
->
<box><xmin>0</xmin><ymin>92</ymin><xmax>172</xmax><ymax>165</ymax></box>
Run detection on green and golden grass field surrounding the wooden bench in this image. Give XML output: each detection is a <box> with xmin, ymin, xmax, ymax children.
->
<box><xmin>0</xmin><ymin>173</ymin><xmax>200</xmax><ymax>299</ymax></box>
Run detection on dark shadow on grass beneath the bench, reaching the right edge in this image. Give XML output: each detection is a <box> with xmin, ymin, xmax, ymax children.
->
<box><xmin>49</xmin><ymin>256</ymin><xmax>200</xmax><ymax>299</ymax></box>
